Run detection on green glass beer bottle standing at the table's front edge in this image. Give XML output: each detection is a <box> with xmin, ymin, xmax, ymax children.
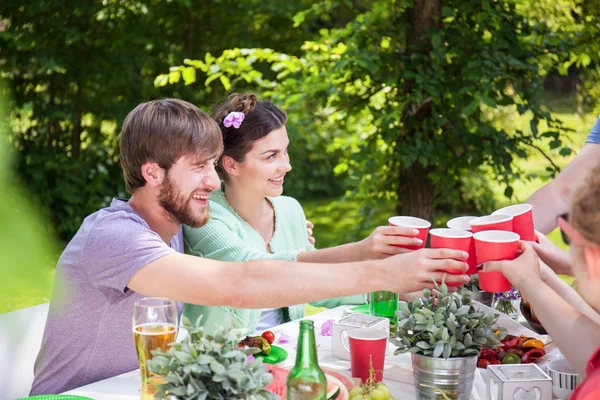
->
<box><xmin>286</xmin><ymin>321</ymin><xmax>327</xmax><ymax>400</ymax></box>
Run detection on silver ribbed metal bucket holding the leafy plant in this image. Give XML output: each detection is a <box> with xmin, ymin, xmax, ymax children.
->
<box><xmin>411</xmin><ymin>354</ymin><xmax>477</xmax><ymax>400</ymax></box>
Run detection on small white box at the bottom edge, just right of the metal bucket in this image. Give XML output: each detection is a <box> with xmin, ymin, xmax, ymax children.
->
<box><xmin>486</xmin><ymin>364</ymin><xmax>552</xmax><ymax>400</ymax></box>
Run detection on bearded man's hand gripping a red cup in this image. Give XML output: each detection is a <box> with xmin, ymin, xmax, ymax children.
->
<box><xmin>378</xmin><ymin>249</ymin><xmax>469</xmax><ymax>294</ymax></box>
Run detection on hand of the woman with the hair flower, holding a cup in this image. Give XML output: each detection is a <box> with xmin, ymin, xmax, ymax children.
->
<box><xmin>358</xmin><ymin>226</ymin><xmax>423</xmax><ymax>259</ymax></box>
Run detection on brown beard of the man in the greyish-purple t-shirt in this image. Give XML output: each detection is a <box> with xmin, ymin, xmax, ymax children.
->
<box><xmin>158</xmin><ymin>173</ymin><xmax>209</xmax><ymax>228</ymax></box>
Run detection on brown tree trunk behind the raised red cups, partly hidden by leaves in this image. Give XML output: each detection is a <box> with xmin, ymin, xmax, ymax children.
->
<box><xmin>396</xmin><ymin>0</ymin><xmax>442</xmax><ymax>221</ymax></box>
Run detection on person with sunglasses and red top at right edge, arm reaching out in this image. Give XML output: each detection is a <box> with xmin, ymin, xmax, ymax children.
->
<box><xmin>484</xmin><ymin>159</ymin><xmax>600</xmax><ymax>400</ymax></box>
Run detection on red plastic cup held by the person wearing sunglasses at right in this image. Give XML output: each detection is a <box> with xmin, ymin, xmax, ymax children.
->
<box><xmin>473</xmin><ymin>231</ymin><xmax>520</xmax><ymax>292</ymax></box>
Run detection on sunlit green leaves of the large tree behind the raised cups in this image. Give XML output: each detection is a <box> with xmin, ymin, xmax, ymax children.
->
<box><xmin>164</xmin><ymin>0</ymin><xmax>570</xmax><ymax>225</ymax></box>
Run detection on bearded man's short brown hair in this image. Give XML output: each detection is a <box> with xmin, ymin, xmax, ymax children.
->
<box><xmin>120</xmin><ymin>99</ymin><xmax>223</xmax><ymax>193</ymax></box>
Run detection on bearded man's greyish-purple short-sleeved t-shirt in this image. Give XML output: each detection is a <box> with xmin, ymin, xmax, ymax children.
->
<box><xmin>31</xmin><ymin>199</ymin><xmax>183</xmax><ymax>395</ymax></box>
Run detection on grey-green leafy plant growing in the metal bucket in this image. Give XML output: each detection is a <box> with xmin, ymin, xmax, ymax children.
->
<box><xmin>392</xmin><ymin>283</ymin><xmax>506</xmax><ymax>359</ymax></box>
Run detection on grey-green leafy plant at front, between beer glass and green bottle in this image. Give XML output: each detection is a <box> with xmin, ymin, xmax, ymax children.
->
<box><xmin>148</xmin><ymin>317</ymin><xmax>275</xmax><ymax>400</ymax></box>
